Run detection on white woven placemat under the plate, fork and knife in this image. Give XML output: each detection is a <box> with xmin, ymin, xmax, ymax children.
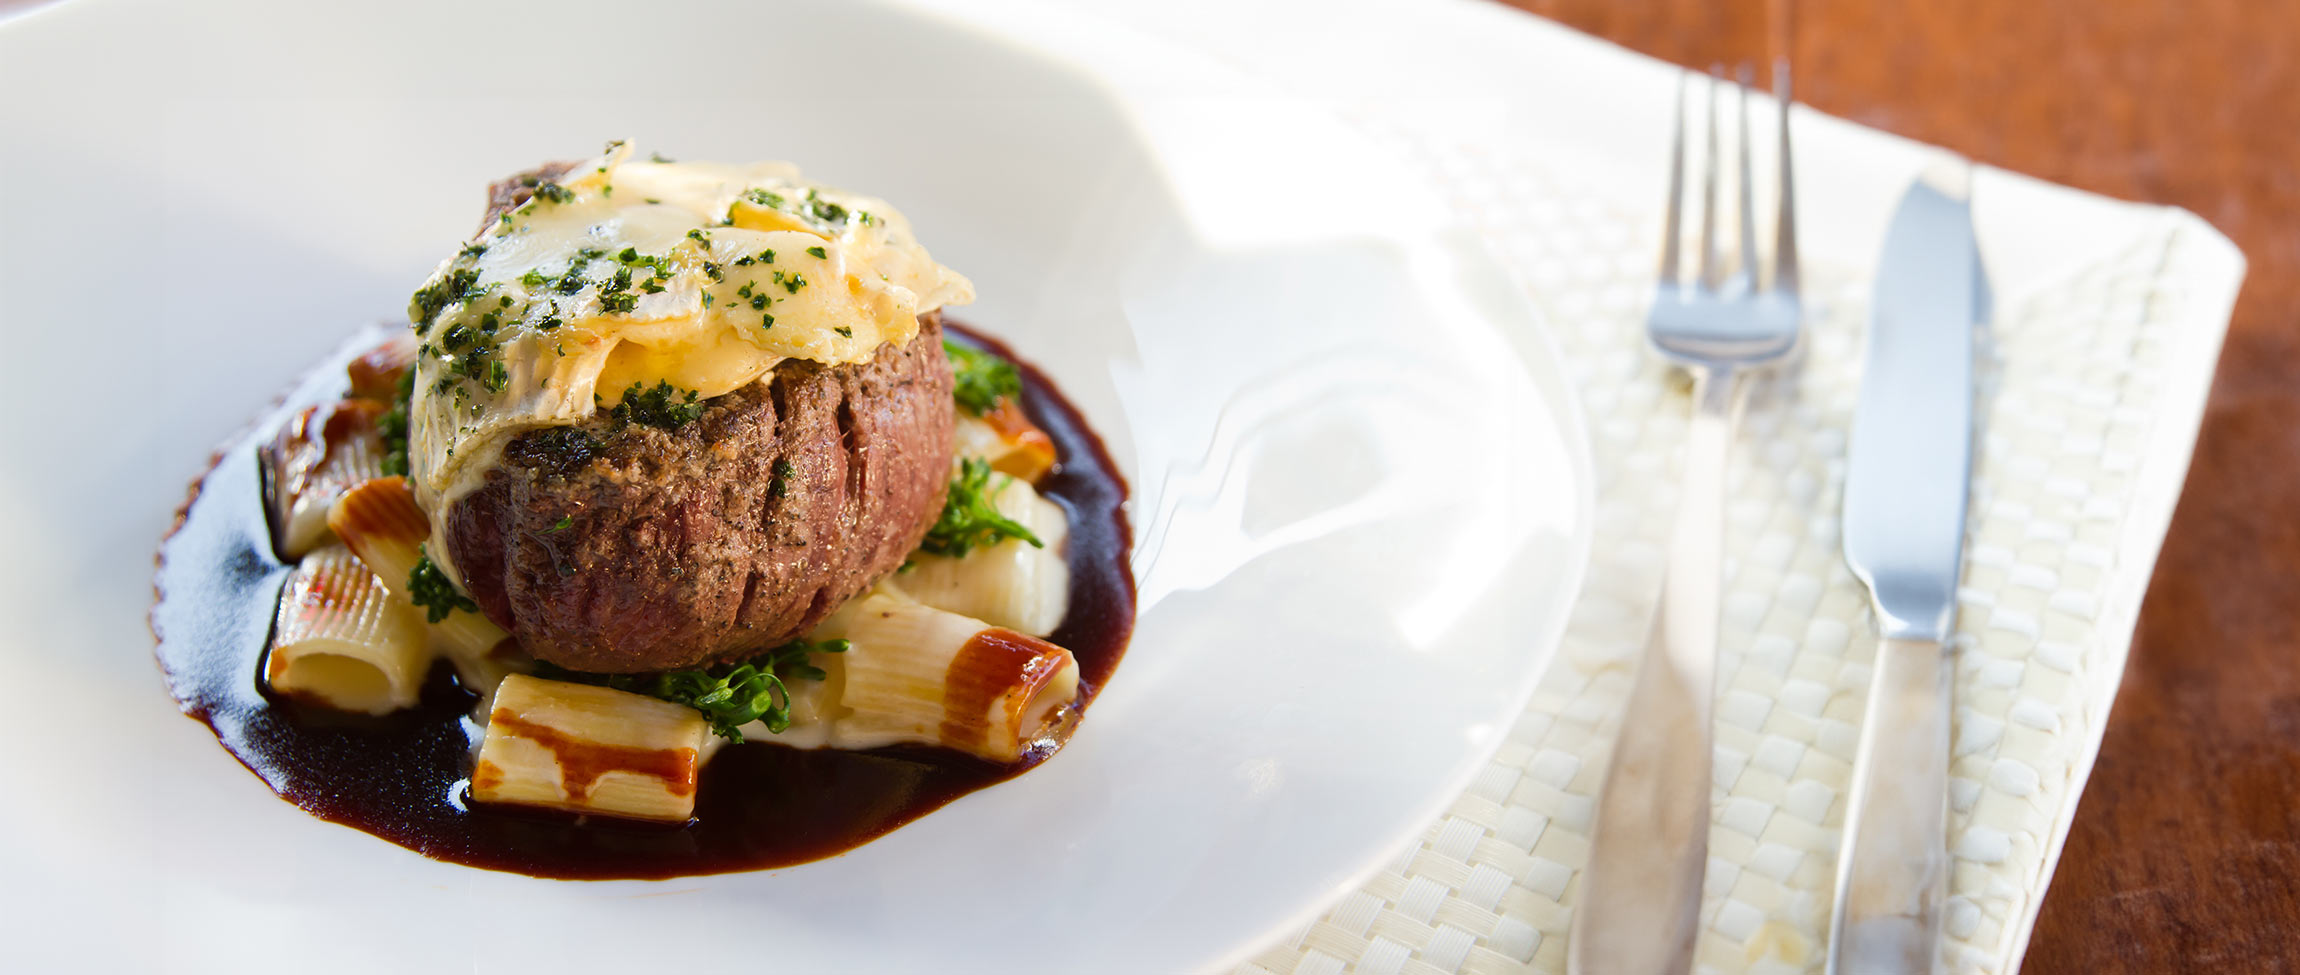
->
<box><xmin>1048</xmin><ymin>0</ymin><xmax>2243</xmax><ymax>973</ymax></box>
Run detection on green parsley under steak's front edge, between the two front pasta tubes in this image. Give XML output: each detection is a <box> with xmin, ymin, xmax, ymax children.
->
<box><xmin>536</xmin><ymin>639</ymin><xmax>851</xmax><ymax>743</ymax></box>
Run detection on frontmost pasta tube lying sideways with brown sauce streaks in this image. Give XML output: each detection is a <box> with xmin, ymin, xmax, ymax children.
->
<box><xmin>472</xmin><ymin>674</ymin><xmax>711</xmax><ymax>823</ymax></box>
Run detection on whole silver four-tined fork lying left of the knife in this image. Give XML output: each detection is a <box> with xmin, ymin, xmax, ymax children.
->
<box><xmin>1566</xmin><ymin>60</ymin><xmax>1799</xmax><ymax>975</ymax></box>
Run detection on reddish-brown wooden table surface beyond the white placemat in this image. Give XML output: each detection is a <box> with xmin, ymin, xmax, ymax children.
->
<box><xmin>1509</xmin><ymin>0</ymin><xmax>2300</xmax><ymax>975</ymax></box>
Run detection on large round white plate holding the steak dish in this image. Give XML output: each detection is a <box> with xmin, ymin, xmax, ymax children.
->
<box><xmin>0</xmin><ymin>0</ymin><xmax>1592</xmax><ymax>973</ymax></box>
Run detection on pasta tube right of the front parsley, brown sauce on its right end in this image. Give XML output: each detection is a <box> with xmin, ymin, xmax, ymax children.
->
<box><xmin>814</xmin><ymin>591</ymin><xmax>1079</xmax><ymax>761</ymax></box>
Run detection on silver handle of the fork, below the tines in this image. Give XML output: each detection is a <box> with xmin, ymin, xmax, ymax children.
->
<box><xmin>1566</xmin><ymin>370</ymin><xmax>1739</xmax><ymax>975</ymax></box>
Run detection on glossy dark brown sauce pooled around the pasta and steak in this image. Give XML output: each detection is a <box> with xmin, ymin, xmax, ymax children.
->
<box><xmin>152</xmin><ymin>324</ymin><xmax>1134</xmax><ymax>881</ymax></box>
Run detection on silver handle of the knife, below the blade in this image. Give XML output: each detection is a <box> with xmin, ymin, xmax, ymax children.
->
<box><xmin>1829</xmin><ymin>639</ymin><xmax>1953</xmax><ymax>975</ymax></box>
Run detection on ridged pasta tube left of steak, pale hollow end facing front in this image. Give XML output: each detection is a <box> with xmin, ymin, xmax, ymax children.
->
<box><xmin>265</xmin><ymin>545</ymin><xmax>432</xmax><ymax>715</ymax></box>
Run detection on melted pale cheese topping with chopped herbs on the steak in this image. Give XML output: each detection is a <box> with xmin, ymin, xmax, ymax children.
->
<box><xmin>407</xmin><ymin>143</ymin><xmax>973</xmax><ymax>582</ymax></box>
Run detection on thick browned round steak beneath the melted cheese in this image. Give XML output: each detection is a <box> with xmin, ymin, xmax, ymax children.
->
<box><xmin>444</xmin><ymin>168</ymin><xmax>952</xmax><ymax>674</ymax></box>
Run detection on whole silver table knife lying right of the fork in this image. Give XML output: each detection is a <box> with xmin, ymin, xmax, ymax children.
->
<box><xmin>1829</xmin><ymin>161</ymin><xmax>1985</xmax><ymax>975</ymax></box>
